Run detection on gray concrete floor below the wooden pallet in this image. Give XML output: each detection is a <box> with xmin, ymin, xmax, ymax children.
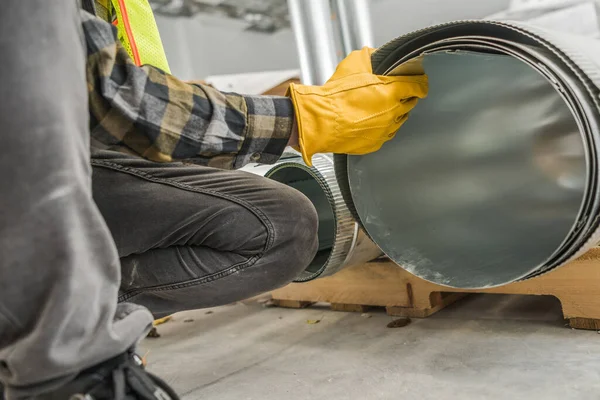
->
<box><xmin>142</xmin><ymin>295</ymin><xmax>600</xmax><ymax>400</ymax></box>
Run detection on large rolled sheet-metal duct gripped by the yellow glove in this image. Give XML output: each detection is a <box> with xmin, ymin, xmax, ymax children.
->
<box><xmin>335</xmin><ymin>21</ymin><xmax>600</xmax><ymax>288</ymax></box>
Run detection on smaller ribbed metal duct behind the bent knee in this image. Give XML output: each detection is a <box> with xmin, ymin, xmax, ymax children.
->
<box><xmin>265</xmin><ymin>154</ymin><xmax>381</xmax><ymax>282</ymax></box>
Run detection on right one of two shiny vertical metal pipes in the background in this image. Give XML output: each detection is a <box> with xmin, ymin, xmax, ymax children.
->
<box><xmin>333</xmin><ymin>0</ymin><xmax>374</xmax><ymax>55</ymax></box>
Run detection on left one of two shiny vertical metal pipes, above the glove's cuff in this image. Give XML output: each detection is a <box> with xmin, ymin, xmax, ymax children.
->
<box><xmin>288</xmin><ymin>0</ymin><xmax>337</xmax><ymax>85</ymax></box>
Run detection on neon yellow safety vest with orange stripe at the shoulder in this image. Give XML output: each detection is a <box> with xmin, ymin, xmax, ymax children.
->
<box><xmin>95</xmin><ymin>0</ymin><xmax>171</xmax><ymax>73</ymax></box>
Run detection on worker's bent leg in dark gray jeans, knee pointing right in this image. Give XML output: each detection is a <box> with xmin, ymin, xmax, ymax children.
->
<box><xmin>93</xmin><ymin>152</ymin><xmax>318</xmax><ymax>317</ymax></box>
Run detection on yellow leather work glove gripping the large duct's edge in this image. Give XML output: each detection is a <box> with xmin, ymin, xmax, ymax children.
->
<box><xmin>288</xmin><ymin>47</ymin><xmax>428</xmax><ymax>165</ymax></box>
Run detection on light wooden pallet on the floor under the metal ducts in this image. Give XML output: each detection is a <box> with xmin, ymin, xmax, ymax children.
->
<box><xmin>272</xmin><ymin>248</ymin><xmax>600</xmax><ymax>330</ymax></box>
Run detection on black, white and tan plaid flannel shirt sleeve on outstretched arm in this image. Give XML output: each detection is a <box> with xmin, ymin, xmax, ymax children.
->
<box><xmin>82</xmin><ymin>11</ymin><xmax>294</xmax><ymax>169</ymax></box>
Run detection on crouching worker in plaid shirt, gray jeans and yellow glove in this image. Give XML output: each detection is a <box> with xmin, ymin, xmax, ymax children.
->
<box><xmin>0</xmin><ymin>0</ymin><xmax>427</xmax><ymax>400</ymax></box>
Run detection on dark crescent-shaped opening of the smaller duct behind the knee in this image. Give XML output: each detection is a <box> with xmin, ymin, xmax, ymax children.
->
<box><xmin>265</xmin><ymin>163</ymin><xmax>336</xmax><ymax>280</ymax></box>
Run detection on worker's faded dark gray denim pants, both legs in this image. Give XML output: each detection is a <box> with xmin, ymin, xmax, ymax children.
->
<box><xmin>0</xmin><ymin>0</ymin><xmax>317</xmax><ymax>398</ymax></box>
